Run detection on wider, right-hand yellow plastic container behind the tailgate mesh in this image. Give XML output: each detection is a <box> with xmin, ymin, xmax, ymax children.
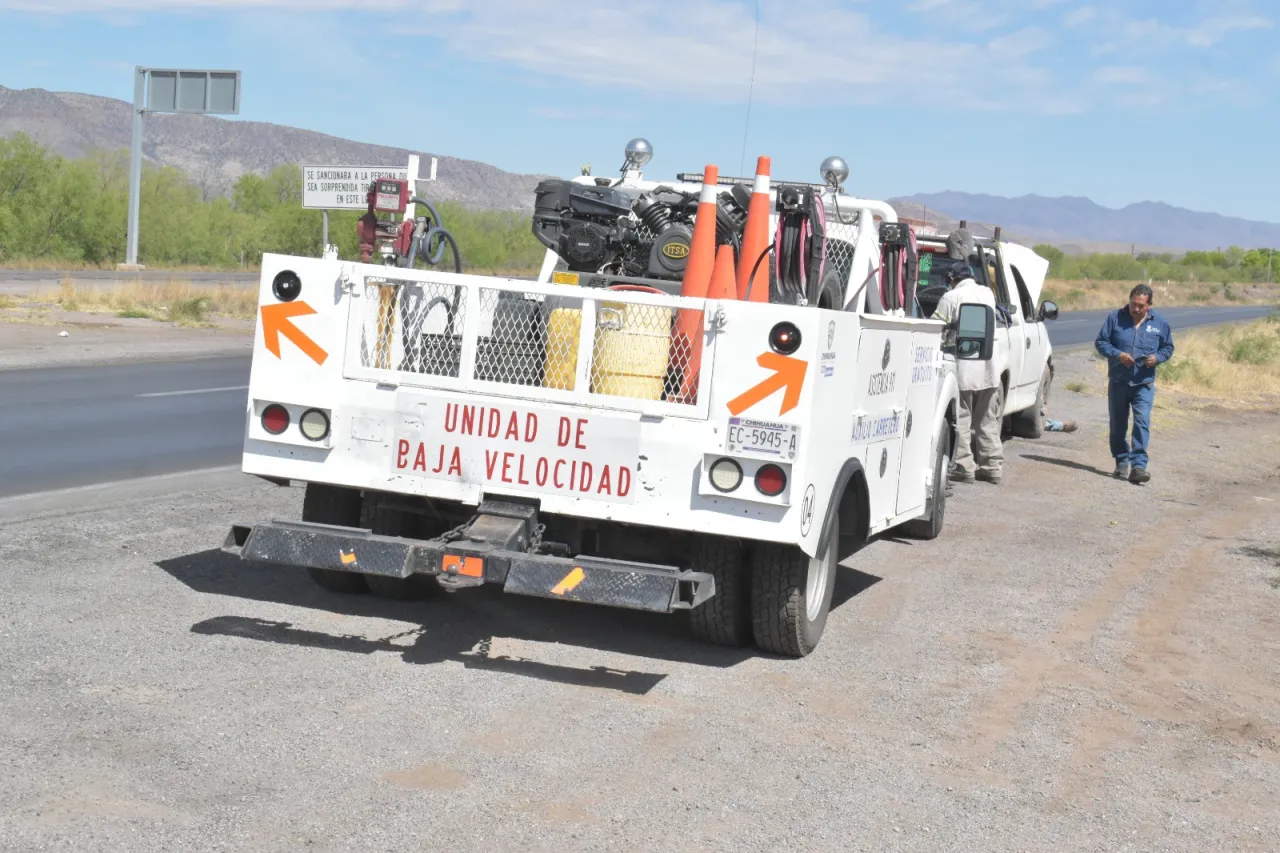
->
<box><xmin>591</xmin><ymin>290</ymin><xmax>672</xmax><ymax>400</ymax></box>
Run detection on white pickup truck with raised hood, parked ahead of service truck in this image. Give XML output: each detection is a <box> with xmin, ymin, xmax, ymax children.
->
<box><xmin>918</xmin><ymin>232</ymin><xmax>1057</xmax><ymax>438</ymax></box>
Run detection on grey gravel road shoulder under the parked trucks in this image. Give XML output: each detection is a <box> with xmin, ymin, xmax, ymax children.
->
<box><xmin>0</xmin><ymin>352</ymin><xmax>1280</xmax><ymax>853</ymax></box>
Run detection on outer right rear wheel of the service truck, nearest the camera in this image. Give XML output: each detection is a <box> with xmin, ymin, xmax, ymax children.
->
<box><xmin>751</xmin><ymin>512</ymin><xmax>840</xmax><ymax>657</ymax></box>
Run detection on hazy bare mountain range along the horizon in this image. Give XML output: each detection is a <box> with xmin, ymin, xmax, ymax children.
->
<box><xmin>0</xmin><ymin>86</ymin><xmax>1280</xmax><ymax>252</ymax></box>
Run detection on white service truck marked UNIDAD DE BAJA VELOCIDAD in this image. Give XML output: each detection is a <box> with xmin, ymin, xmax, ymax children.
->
<box><xmin>223</xmin><ymin>144</ymin><xmax>995</xmax><ymax>656</ymax></box>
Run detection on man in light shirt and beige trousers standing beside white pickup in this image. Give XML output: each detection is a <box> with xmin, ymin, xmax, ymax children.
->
<box><xmin>933</xmin><ymin>264</ymin><xmax>1005</xmax><ymax>483</ymax></box>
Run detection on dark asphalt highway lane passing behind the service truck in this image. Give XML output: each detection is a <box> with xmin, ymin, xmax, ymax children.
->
<box><xmin>0</xmin><ymin>306</ymin><xmax>1271</xmax><ymax>497</ymax></box>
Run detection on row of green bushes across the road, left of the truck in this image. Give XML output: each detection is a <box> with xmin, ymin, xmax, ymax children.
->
<box><xmin>0</xmin><ymin>133</ymin><xmax>543</xmax><ymax>270</ymax></box>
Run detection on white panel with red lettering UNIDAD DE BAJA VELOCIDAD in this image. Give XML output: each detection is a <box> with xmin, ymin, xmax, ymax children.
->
<box><xmin>390</xmin><ymin>393</ymin><xmax>640</xmax><ymax>503</ymax></box>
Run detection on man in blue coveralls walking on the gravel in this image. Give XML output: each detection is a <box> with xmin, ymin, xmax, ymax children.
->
<box><xmin>1094</xmin><ymin>284</ymin><xmax>1174</xmax><ymax>483</ymax></box>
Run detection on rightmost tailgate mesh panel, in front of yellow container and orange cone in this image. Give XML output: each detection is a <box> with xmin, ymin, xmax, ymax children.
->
<box><xmin>591</xmin><ymin>301</ymin><xmax>703</xmax><ymax>405</ymax></box>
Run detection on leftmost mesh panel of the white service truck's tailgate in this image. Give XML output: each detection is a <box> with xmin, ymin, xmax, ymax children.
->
<box><xmin>360</xmin><ymin>279</ymin><xmax>466</xmax><ymax>379</ymax></box>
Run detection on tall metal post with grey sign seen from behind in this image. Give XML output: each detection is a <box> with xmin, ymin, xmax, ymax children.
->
<box><xmin>120</xmin><ymin>65</ymin><xmax>241</xmax><ymax>269</ymax></box>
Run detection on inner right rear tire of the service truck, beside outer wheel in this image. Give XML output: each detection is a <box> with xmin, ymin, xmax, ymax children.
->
<box><xmin>689</xmin><ymin>534</ymin><xmax>751</xmax><ymax>648</ymax></box>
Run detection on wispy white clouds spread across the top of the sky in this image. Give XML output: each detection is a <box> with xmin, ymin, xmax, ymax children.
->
<box><xmin>0</xmin><ymin>0</ymin><xmax>1274</xmax><ymax>115</ymax></box>
